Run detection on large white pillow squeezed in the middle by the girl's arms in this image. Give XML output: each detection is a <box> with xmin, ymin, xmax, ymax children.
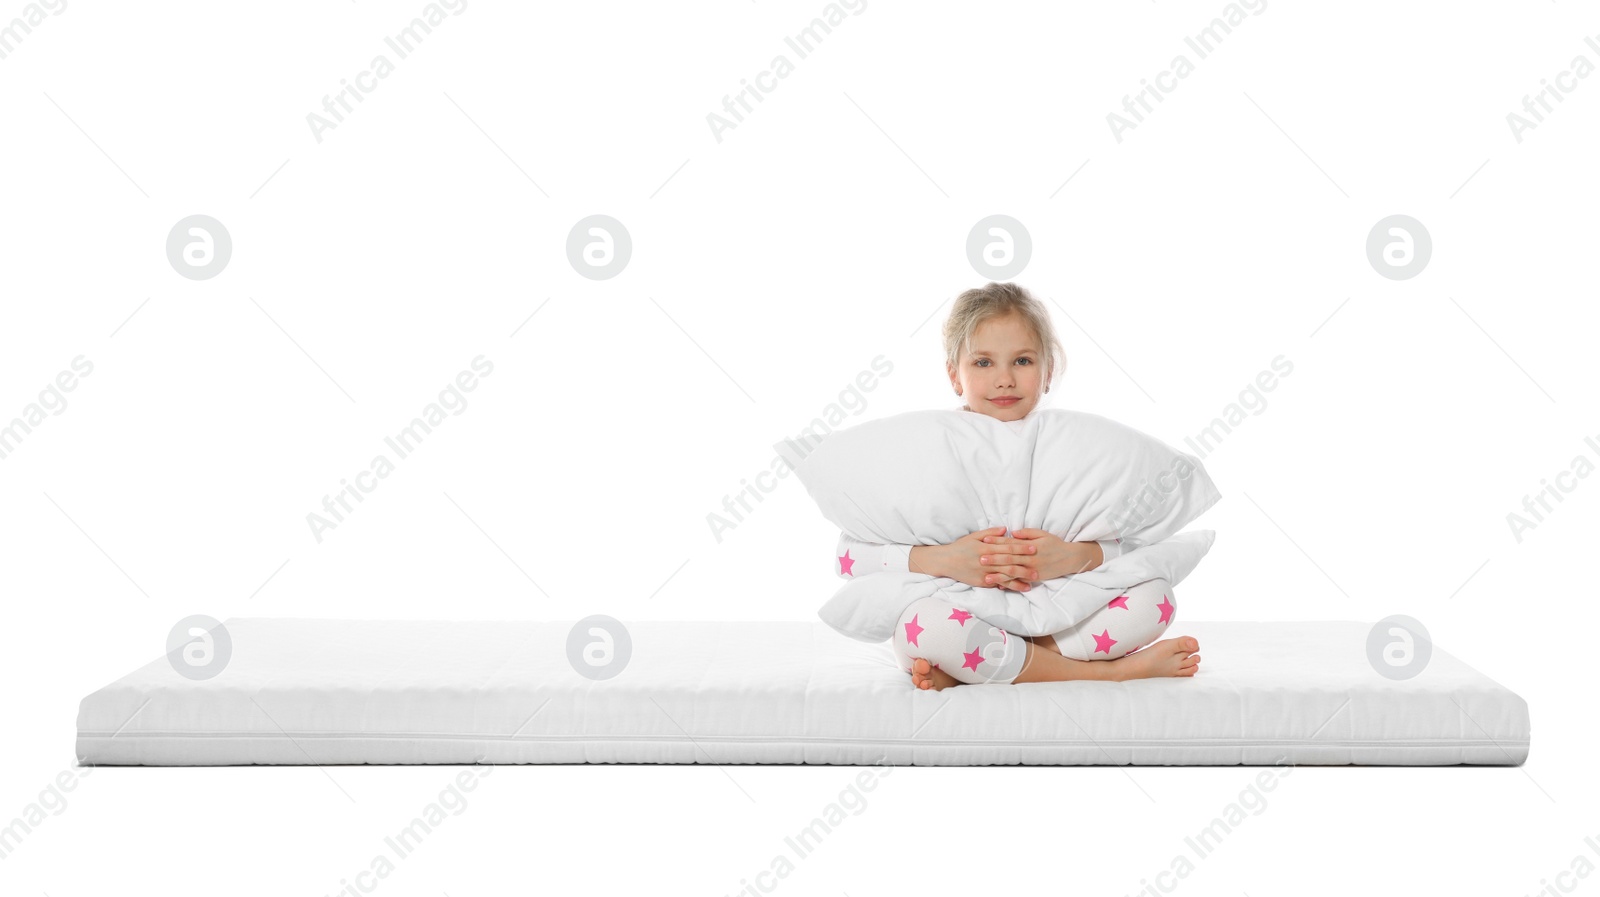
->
<box><xmin>774</xmin><ymin>409</ymin><xmax>1221</xmax><ymax>641</ymax></box>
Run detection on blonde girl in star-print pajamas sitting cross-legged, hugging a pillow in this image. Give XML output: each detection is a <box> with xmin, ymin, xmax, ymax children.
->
<box><xmin>838</xmin><ymin>283</ymin><xmax>1200</xmax><ymax>689</ymax></box>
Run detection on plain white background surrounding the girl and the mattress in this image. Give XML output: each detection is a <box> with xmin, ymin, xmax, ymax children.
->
<box><xmin>0</xmin><ymin>0</ymin><xmax>1600</xmax><ymax>897</ymax></box>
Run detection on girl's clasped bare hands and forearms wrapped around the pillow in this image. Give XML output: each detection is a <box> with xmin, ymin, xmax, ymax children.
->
<box><xmin>910</xmin><ymin>526</ymin><xmax>1102</xmax><ymax>592</ymax></box>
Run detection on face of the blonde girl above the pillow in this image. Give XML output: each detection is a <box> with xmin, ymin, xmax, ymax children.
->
<box><xmin>950</xmin><ymin>315</ymin><xmax>1046</xmax><ymax>421</ymax></box>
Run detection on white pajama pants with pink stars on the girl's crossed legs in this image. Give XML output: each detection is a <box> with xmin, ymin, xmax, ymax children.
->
<box><xmin>890</xmin><ymin>579</ymin><xmax>1178</xmax><ymax>684</ymax></box>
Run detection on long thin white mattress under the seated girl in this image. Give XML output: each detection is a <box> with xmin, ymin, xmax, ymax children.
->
<box><xmin>77</xmin><ymin>619</ymin><xmax>1530</xmax><ymax>766</ymax></box>
